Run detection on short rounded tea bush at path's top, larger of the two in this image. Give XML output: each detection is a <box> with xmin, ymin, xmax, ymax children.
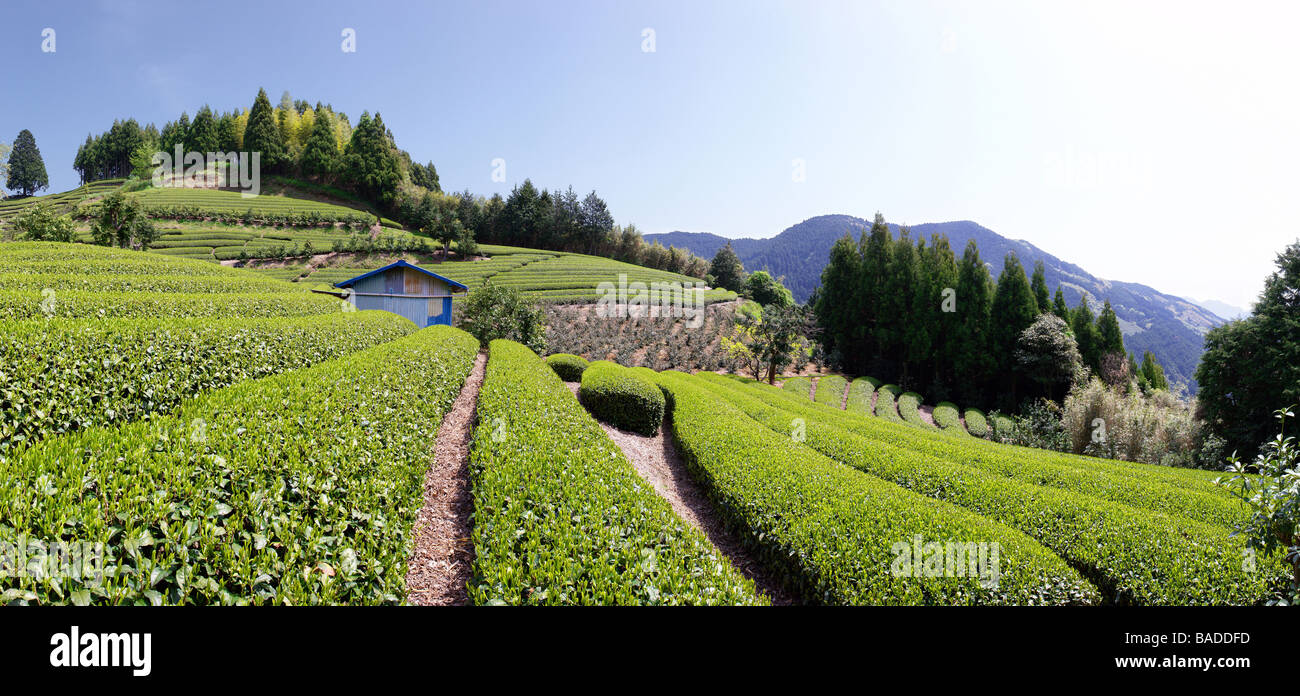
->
<box><xmin>577</xmin><ymin>360</ymin><xmax>664</xmax><ymax>436</ymax></box>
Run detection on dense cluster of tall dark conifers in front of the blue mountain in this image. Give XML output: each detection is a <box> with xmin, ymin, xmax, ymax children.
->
<box><xmin>809</xmin><ymin>213</ymin><xmax>1149</xmax><ymax>410</ymax></box>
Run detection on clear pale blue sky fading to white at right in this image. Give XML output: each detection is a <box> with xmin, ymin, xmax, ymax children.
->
<box><xmin>0</xmin><ymin>0</ymin><xmax>1300</xmax><ymax>306</ymax></box>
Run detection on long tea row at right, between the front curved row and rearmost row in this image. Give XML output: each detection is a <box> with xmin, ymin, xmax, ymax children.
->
<box><xmin>709</xmin><ymin>380</ymin><xmax>1287</xmax><ymax>605</ymax></box>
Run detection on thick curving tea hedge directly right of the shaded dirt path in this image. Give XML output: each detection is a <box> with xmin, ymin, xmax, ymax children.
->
<box><xmin>659</xmin><ymin>372</ymin><xmax>1099</xmax><ymax>605</ymax></box>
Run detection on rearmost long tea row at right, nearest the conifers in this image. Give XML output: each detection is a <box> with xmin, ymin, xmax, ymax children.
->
<box><xmin>722</xmin><ymin>374</ymin><xmax>1245</xmax><ymax>528</ymax></box>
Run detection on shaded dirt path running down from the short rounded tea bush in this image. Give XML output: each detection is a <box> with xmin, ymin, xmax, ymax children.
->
<box><xmin>564</xmin><ymin>382</ymin><xmax>798</xmax><ymax>606</ymax></box>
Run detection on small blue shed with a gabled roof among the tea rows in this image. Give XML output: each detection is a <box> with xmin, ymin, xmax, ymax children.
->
<box><xmin>334</xmin><ymin>261</ymin><xmax>468</xmax><ymax>327</ymax></box>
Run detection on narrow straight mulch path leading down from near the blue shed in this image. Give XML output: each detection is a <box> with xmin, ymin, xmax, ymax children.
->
<box><xmin>407</xmin><ymin>353</ymin><xmax>488</xmax><ymax>606</ymax></box>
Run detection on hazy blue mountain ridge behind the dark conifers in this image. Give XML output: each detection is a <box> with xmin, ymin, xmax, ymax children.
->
<box><xmin>645</xmin><ymin>215</ymin><xmax>1225</xmax><ymax>393</ymax></box>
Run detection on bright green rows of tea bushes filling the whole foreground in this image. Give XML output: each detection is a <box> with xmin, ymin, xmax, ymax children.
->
<box><xmin>0</xmin><ymin>242</ymin><xmax>1287</xmax><ymax>605</ymax></box>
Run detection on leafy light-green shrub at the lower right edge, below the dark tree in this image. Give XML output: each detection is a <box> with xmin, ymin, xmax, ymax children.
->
<box><xmin>1217</xmin><ymin>408</ymin><xmax>1300</xmax><ymax>604</ymax></box>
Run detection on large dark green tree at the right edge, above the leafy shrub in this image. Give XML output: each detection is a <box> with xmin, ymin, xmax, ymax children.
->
<box><xmin>1196</xmin><ymin>242</ymin><xmax>1300</xmax><ymax>459</ymax></box>
